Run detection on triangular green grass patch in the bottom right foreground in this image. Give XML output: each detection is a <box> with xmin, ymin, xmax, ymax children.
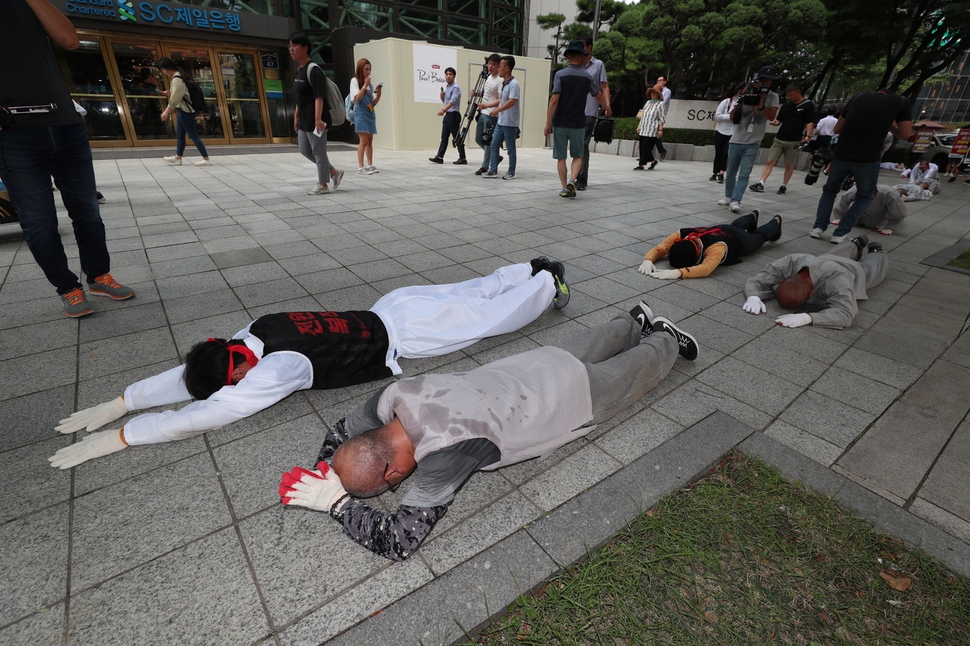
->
<box><xmin>473</xmin><ymin>455</ymin><xmax>970</xmax><ymax>646</ymax></box>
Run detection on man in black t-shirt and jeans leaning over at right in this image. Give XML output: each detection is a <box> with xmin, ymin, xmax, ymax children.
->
<box><xmin>809</xmin><ymin>89</ymin><xmax>913</xmax><ymax>244</ymax></box>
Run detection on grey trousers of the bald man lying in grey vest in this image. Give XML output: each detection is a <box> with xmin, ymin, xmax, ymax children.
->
<box><xmin>560</xmin><ymin>314</ymin><xmax>679</xmax><ymax>424</ymax></box>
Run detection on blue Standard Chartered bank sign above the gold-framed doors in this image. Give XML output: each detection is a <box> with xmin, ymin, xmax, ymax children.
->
<box><xmin>55</xmin><ymin>0</ymin><xmax>243</xmax><ymax>33</ymax></box>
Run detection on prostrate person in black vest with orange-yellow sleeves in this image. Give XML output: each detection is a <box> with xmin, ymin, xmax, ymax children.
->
<box><xmin>638</xmin><ymin>209</ymin><xmax>781</xmax><ymax>280</ymax></box>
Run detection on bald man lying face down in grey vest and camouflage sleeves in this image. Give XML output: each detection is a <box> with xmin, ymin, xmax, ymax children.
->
<box><xmin>279</xmin><ymin>302</ymin><xmax>698</xmax><ymax>561</ymax></box>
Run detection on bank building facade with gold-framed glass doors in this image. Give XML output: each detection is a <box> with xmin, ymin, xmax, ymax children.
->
<box><xmin>53</xmin><ymin>0</ymin><xmax>526</xmax><ymax>146</ymax></box>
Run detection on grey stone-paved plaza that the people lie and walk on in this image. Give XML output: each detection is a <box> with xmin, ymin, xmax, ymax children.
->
<box><xmin>0</xmin><ymin>145</ymin><xmax>970</xmax><ymax>646</ymax></box>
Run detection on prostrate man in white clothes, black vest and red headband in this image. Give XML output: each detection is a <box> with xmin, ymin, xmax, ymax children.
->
<box><xmin>49</xmin><ymin>257</ymin><xmax>569</xmax><ymax>469</ymax></box>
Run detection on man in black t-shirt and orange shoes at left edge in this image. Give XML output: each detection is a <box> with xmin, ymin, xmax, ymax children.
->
<box><xmin>0</xmin><ymin>0</ymin><xmax>135</xmax><ymax>318</ymax></box>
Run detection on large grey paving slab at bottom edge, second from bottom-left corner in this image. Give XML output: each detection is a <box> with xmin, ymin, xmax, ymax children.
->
<box><xmin>70</xmin><ymin>528</ymin><xmax>269</xmax><ymax>645</ymax></box>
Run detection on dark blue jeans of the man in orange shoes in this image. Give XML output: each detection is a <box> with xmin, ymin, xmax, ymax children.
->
<box><xmin>0</xmin><ymin>121</ymin><xmax>111</xmax><ymax>294</ymax></box>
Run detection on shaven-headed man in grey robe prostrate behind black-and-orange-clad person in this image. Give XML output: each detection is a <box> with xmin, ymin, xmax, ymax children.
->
<box><xmin>742</xmin><ymin>236</ymin><xmax>889</xmax><ymax>329</ymax></box>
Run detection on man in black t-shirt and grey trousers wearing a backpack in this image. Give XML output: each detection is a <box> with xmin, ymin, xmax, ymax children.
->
<box><xmin>289</xmin><ymin>33</ymin><xmax>344</xmax><ymax>195</ymax></box>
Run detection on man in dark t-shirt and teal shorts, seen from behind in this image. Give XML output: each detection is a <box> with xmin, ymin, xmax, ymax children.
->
<box><xmin>545</xmin><ymin>40</ymin><xmax>609</xmax><ymax>197</ymax></box>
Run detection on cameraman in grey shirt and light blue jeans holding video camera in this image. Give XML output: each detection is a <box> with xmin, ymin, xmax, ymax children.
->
<box><xmin>718</xmin><ymin>65</ymin><xmax>779</xmax><ymax>213</ymax></box>
